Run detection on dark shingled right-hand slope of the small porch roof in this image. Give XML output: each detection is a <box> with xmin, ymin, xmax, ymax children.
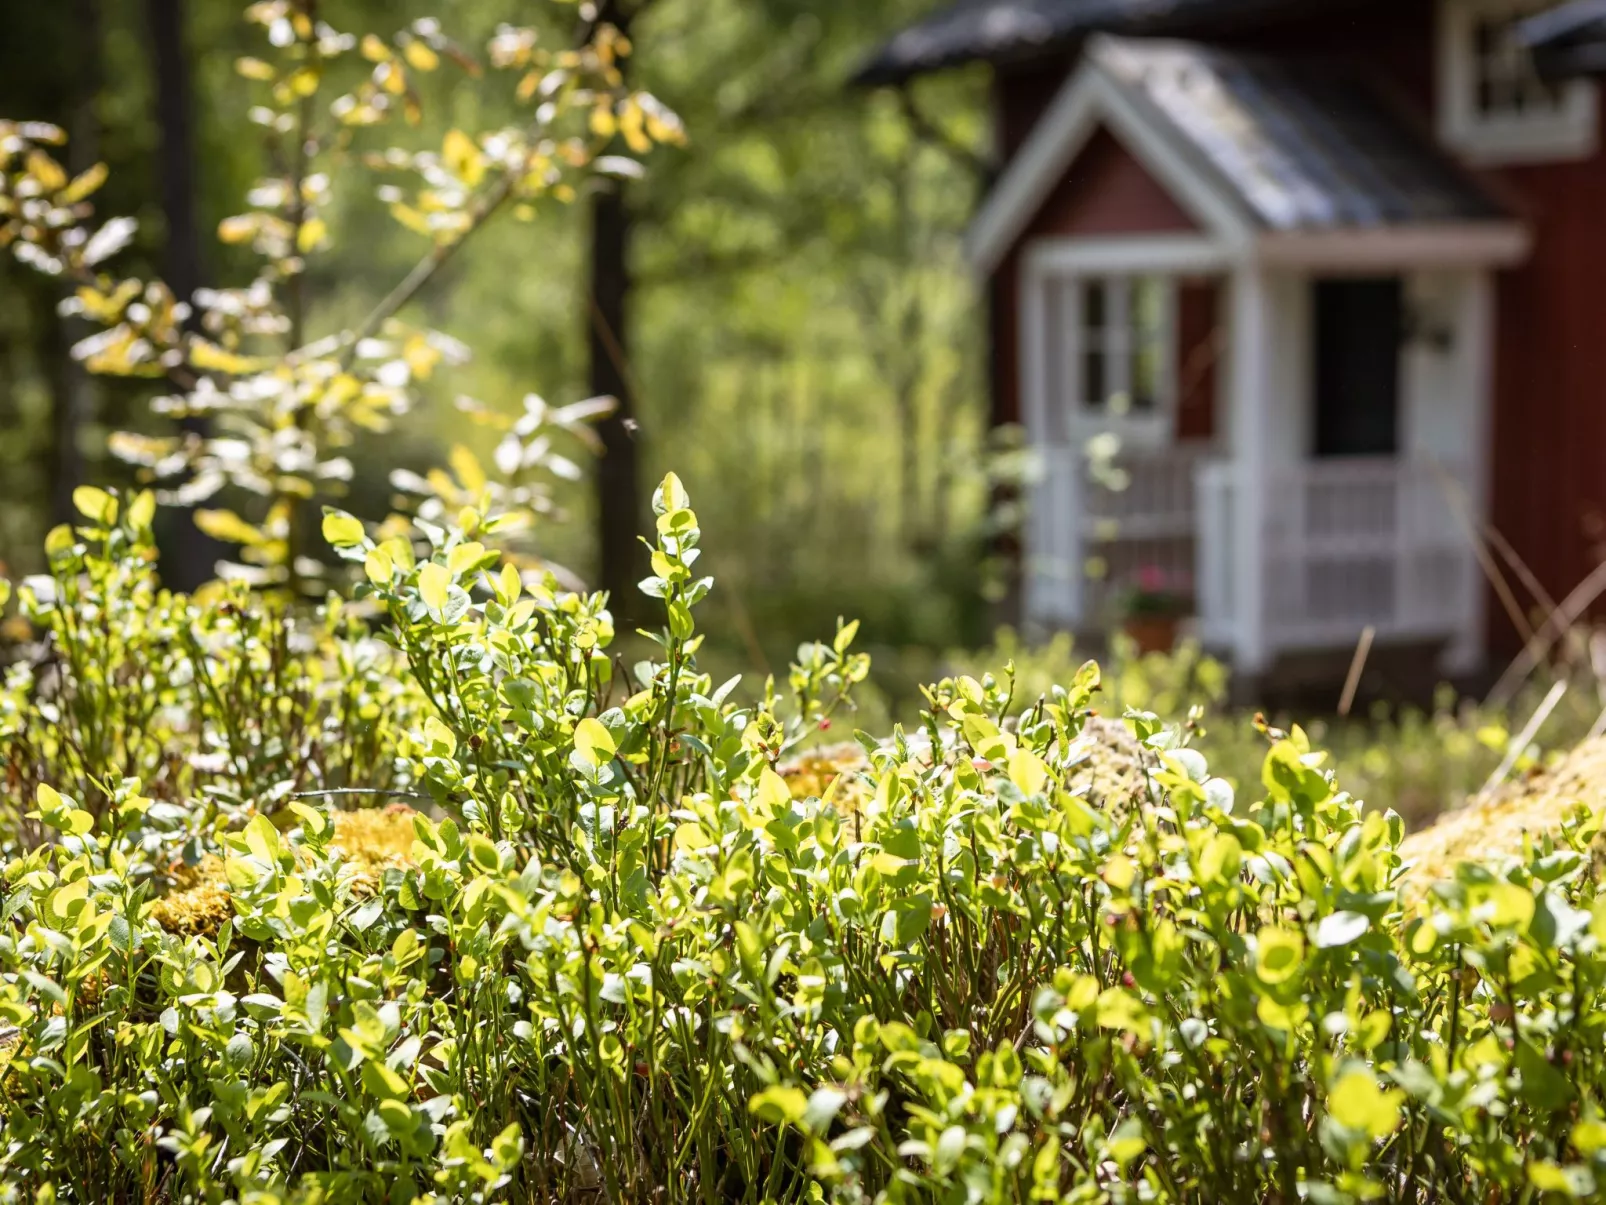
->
<box><xmin>1090</xmin><ymin>37</ymin><xmax>1508</xmax><ymax>230</ymax></box>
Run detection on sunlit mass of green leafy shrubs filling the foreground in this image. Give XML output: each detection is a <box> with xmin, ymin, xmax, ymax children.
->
<box><xmin>0</xmin><ymin>477</ymin><xmax>1606</xmax><ymax>1203</ymax></box>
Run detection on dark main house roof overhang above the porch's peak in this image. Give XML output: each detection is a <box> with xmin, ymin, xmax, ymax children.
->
<box><xmin>856</xmin><ymin>0</ymin><xmax>1347</xmax><ymax>84</ymax></box>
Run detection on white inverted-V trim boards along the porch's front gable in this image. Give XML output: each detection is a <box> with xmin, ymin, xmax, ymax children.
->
<box><xmin>965</xmin><ymin>45</ymin><xmax>1254</xmax><ymax>275</ymax></box>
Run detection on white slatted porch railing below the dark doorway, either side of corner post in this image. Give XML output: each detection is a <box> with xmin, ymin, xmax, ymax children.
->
<box><xmin>1198</xmin><ymin>458</ymin><xmax>1474</xmax><ymax>656</ymax></box>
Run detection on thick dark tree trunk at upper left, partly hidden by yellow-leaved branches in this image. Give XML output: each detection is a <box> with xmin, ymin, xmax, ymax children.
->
<box><xmin>145</xmin><ymin>0</ymin><xmax>222</xmax><ymax>590</ymax></box>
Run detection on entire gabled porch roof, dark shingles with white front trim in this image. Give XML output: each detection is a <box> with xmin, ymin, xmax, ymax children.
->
<box><xmin>970</xmin><ymin>35</ymin><xmax>1521</xmax><ymax>272</ymax></box>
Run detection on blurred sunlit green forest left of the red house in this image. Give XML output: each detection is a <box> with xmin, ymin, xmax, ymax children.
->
<box><xmin>0</xmin><ymin>0</ymin><xmax>1010</xmax><ymax>696</ymax></box>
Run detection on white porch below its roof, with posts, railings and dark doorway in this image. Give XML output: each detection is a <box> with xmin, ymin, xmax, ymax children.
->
<box><xmin>1025</xmin><ymin>255</ymin><xmax>1490</xmax><ymax>673</ymax></box>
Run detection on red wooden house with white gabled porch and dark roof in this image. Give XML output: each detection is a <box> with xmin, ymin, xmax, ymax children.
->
<box><xmin>862</xmin><ymin>0</ymin><xmax>1606</xmax><ymax>673</ymax></box>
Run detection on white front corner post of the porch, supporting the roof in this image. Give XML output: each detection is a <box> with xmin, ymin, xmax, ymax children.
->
<box><xmin>1227</xmin><ymin>262</ymin><xmax>1274</xmax><ymax>675</ymax></box>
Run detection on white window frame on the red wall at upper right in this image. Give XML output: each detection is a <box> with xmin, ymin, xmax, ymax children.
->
<box><xmin>1437</xmin><ymin>0</ymin><xmax>1600</xmax><ymax>165</ymax></box>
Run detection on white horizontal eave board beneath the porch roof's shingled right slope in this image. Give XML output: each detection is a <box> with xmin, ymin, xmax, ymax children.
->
<box><xmin>1256</xmin><ymin>222</ymin><xmax>1532</xmax><ymax>273</ymax></box>
